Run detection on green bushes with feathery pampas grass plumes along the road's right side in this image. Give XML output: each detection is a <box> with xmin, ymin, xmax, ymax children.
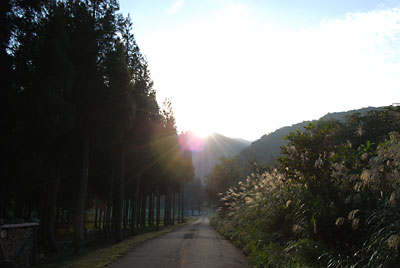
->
<box><xmin>213</xmin><ymin>107</ymin><xmax>400</xmax><ymax>267</ymax></box>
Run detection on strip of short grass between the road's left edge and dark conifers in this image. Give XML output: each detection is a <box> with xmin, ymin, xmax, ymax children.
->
<box><xmin>36</xmin><ymin>218</ymin><xmax>195</xmax><ymax>268</ymax></box>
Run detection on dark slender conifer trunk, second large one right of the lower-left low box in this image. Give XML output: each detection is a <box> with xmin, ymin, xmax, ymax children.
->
<box><xmin>74</xmin><ymin>122</ymin><xmax>89</xmax><ymax>254</ymax></box>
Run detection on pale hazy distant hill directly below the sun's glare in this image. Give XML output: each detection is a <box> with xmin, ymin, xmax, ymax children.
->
<box><xmin>192</xmin><ymin>133</ymin><xmax>250</xmax><ymax>183</ymax></box>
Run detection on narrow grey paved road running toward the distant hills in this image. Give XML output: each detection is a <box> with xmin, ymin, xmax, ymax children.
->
<box><xmin>111</xmin><ymin>217</ymin><xmax>250</xmax><ymax>268</ymax></box>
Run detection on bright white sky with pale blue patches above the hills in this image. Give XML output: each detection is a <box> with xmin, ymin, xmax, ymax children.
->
<box><xmin>120</xmin><ymin>0</ymin><xmax>400</xmax><ymax>141</ymax></box>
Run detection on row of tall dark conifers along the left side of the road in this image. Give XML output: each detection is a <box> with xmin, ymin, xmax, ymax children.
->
<box><xmin>0</xmin><ymin>0</ymin><xmax>193</xmax><ymax>253</ymax></box>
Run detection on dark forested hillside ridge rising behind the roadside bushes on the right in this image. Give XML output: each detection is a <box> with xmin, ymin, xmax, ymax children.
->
<box><xmin>235</xmin><ymin>107</ymin><xmax>380</xmax><ymax>167</ymax></box>
